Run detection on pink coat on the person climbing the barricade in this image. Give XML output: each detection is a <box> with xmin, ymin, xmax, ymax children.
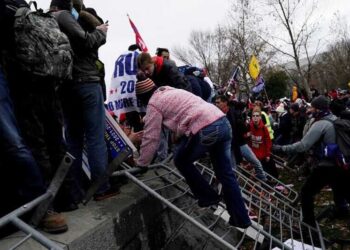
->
<box><xmin>137</xmin><ymin>86</ymin><xmax>225</xmax><ymax>166</ymax></box>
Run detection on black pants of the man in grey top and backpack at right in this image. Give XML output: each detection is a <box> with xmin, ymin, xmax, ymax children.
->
<box><xmin>301</xmin><ymin>164</ymin><xmax>350</xmax><ymax>226</ymax></box>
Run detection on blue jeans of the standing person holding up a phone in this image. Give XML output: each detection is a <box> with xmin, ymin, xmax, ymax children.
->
<box><xmin>62</xmin><ymin>83</ymin><xmax>109</xmax><ymax>196</ymax></box>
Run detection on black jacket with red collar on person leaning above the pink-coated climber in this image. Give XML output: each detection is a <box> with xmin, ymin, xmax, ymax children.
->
<box><xmin>151</xmin><ymin>60</ymin><xmax>192</xmax><ymax>92</ymax></box>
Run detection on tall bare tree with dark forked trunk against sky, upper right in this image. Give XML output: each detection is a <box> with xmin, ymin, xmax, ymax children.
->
<box><xmin>261</xmin><ymin>0</ymin><xmax>320</xmax><ymax>95</ymax></box>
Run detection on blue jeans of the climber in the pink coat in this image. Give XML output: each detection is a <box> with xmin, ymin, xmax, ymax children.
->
<box><xmin>174</xmin><ymin>117</ymin><xmax>250</xmax><ymax>225</ymax></box>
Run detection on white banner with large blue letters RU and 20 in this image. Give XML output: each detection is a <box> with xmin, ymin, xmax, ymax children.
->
<box><xmin>107</xmin><ymin>51</ymin><xmax>146</xmax><ymax>117</ymax></box>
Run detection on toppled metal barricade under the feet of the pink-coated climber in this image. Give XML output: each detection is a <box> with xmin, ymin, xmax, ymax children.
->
<box><xmin>113</xmin><ymin>159</ymin><xmax>325</xmax><ymax>249</ymax></box>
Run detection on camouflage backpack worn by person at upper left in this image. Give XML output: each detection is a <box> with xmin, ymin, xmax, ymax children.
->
<box><xmin>13</xmin><ymin>2</ymin><xmax>73</xmax><ymax>79</ymax></box>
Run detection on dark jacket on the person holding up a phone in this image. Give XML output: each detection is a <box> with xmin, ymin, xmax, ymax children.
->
<box><xmin>54</xmin><ymin>10</ymin><xmax>106</xmax><ymax>83</ymax></box>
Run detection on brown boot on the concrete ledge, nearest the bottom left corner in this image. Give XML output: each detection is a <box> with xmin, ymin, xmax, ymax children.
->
<box><xmin>40</xmin><ymin>210</ymin><xmax>68</xmax><ymax>234</ymax></box>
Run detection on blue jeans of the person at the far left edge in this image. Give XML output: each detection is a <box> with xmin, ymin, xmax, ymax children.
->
<box><xmin>0</xmin><ymin>68</ymin><xmax>46</xmax><ymax>202</ymax></box>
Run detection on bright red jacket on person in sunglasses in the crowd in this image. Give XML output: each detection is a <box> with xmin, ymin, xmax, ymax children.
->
<box><xmin>249</xmin><ymin>120</ymin><xmax>272</xmax><ymax>160</ymax></box>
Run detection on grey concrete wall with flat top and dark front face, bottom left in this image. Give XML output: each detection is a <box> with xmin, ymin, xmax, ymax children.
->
<box><xmin>0</xmin><ymin>172</ymin><xmax>230</xmax><ymax>250</ymax></box>
